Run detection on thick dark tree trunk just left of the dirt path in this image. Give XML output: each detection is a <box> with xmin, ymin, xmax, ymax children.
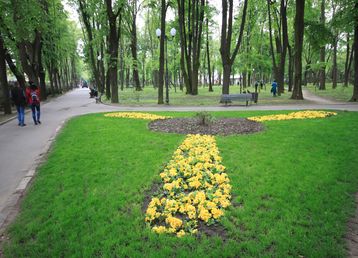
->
<box><xmin>291</xmin><ymin>0</ymin><xmax>305</xmax><ymax>99</ymax></box>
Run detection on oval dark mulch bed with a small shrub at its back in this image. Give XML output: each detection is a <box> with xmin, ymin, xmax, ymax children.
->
<box><xmin>148</xmin><ymin>118</ymin><xmax>264</xmax><ymax>135</ymax></box>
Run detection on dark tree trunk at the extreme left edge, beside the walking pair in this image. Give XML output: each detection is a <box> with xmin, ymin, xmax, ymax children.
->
<box><xmin>0</xmin><ymin>34</ymin><xmax>11</xmax><ymax>114</ymax></box>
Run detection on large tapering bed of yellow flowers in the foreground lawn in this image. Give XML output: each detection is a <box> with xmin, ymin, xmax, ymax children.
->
<box><xmin>145</xmin><ymin>135</ymin><xmax>231</xmax><ymax>237</ymax></box>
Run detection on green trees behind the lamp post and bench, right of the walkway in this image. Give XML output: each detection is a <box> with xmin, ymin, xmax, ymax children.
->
<box><xmin>73</xmin><ymin>0</ymin><xmax>358</xmax><ymax>104</ymax></box>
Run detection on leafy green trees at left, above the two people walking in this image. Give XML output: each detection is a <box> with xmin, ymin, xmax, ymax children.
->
<box><xmin>0</xmin><ymin>0</ymin><xmax>79</xmax><ymax>113</ymax></box>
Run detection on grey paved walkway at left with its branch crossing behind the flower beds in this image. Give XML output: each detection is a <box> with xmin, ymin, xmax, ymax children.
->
<box><xmin>0</xmin><ymin>89</ymin><xmax>358</xmax><ymax>231</ymax></box>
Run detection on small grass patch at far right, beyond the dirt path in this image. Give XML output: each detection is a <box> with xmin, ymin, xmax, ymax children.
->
<box><xmin>307</xmin><ymin>83</ymin><xmax>353</xmax><ymax>102</ymax></box>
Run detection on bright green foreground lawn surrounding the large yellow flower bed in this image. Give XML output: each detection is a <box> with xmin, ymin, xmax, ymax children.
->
<box><xmin>4</xmin><ymin>111</ymin><xmax>358</xmax><ymax>257</ymax></box>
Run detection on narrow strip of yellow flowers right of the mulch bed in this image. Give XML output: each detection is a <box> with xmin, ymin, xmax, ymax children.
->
<box><xmin>247</xmin><ymin>110</ymin><xmax>337</xmax><ymax>122</ymax></box>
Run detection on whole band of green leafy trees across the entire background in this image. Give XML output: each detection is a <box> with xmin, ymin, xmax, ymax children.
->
<box><xmin>0</xmin><ymin>0</ymin><xmax>358</xmax><ymax>110</ymax></box>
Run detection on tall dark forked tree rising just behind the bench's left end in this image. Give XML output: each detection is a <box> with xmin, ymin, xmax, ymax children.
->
<box><xmin>220</xmin><ymin>0</ymin><xmax>248</xmax><ymax>94</ymax></box>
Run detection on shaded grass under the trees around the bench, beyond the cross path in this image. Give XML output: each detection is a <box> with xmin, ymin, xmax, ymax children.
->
<box><xmin>103</xmin><ymin>84</ymin><xmax>309</xmax><ymax>106</ymax></box>
